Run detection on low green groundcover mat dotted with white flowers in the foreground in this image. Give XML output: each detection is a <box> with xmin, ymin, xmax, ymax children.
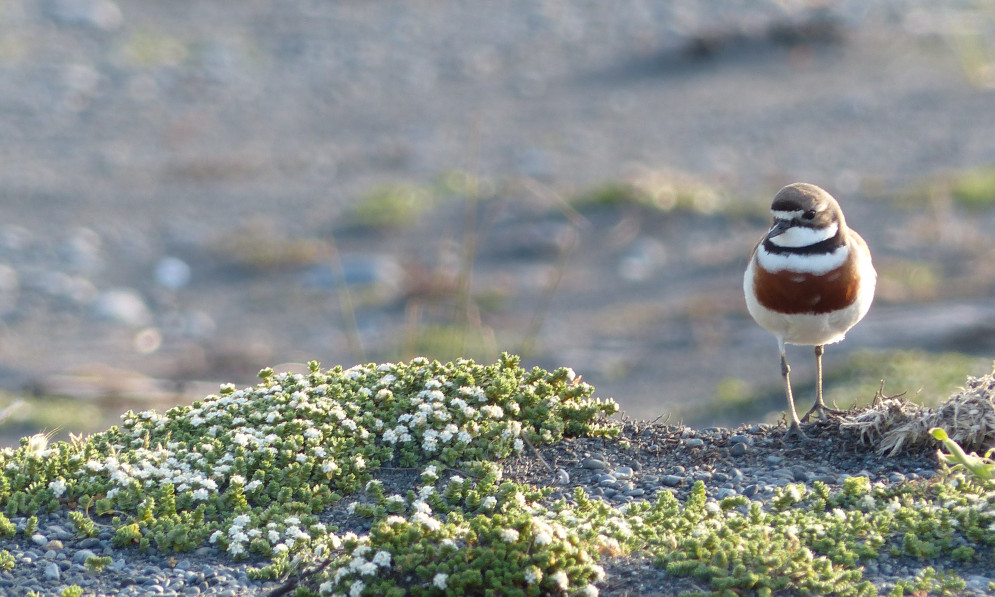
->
<box><xmin>0</xmin><ymin>355</ymin><xmax>995</xmax><ymax>597</ymax></box>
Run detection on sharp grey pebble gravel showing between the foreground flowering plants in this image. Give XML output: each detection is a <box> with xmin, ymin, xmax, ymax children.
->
<box><xmin>7</xmin><ymin>420</ymin><xmax>995</xmax><ymax>596</ymax></box>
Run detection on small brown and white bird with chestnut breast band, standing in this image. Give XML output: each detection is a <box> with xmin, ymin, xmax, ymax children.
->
<box><xmin>743</xmin><ymin>183</ymin><xmax>877</xmax><ymax>438</ymax></box>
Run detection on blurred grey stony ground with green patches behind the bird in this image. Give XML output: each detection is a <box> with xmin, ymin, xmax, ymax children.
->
<box><xmin>0</xmin><ymin>0</ymin><xmax>995</xmax><ymax>445</ymax></box>
